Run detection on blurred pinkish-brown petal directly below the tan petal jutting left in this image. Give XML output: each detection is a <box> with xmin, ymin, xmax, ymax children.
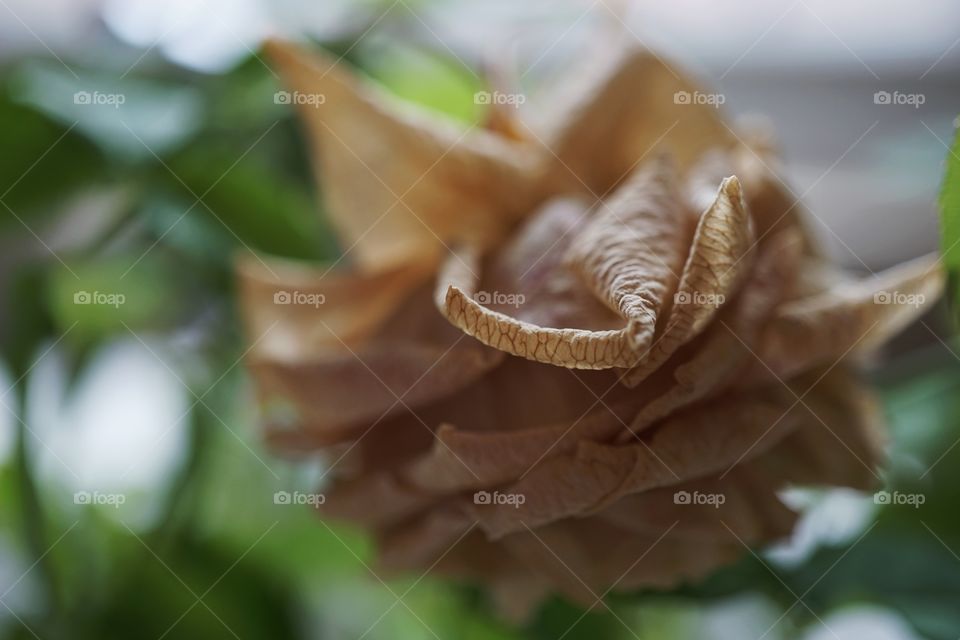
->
<box><xmin>248</xmin><ymin>276</ymin><xmax>503</xmax><ymax>446</ymax></box>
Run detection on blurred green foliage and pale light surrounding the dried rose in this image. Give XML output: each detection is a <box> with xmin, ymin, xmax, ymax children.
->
<box><xmin>0</xmin><ymin>0</ymin><xmax>960</xmax><ymax>640</ymax></box>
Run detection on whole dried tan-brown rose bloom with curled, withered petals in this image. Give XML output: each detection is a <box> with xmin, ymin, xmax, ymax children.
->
<box><xmin>240</xmin><ymin>37</ymin><xmax>942</xmax><ymax>616</ymax></box>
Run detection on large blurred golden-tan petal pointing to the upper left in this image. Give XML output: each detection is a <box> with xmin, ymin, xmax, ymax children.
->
<box><xmin>267</xmin><ymin>42</ymin><xmax>536</xmax><ymax>271</ymax></box>
